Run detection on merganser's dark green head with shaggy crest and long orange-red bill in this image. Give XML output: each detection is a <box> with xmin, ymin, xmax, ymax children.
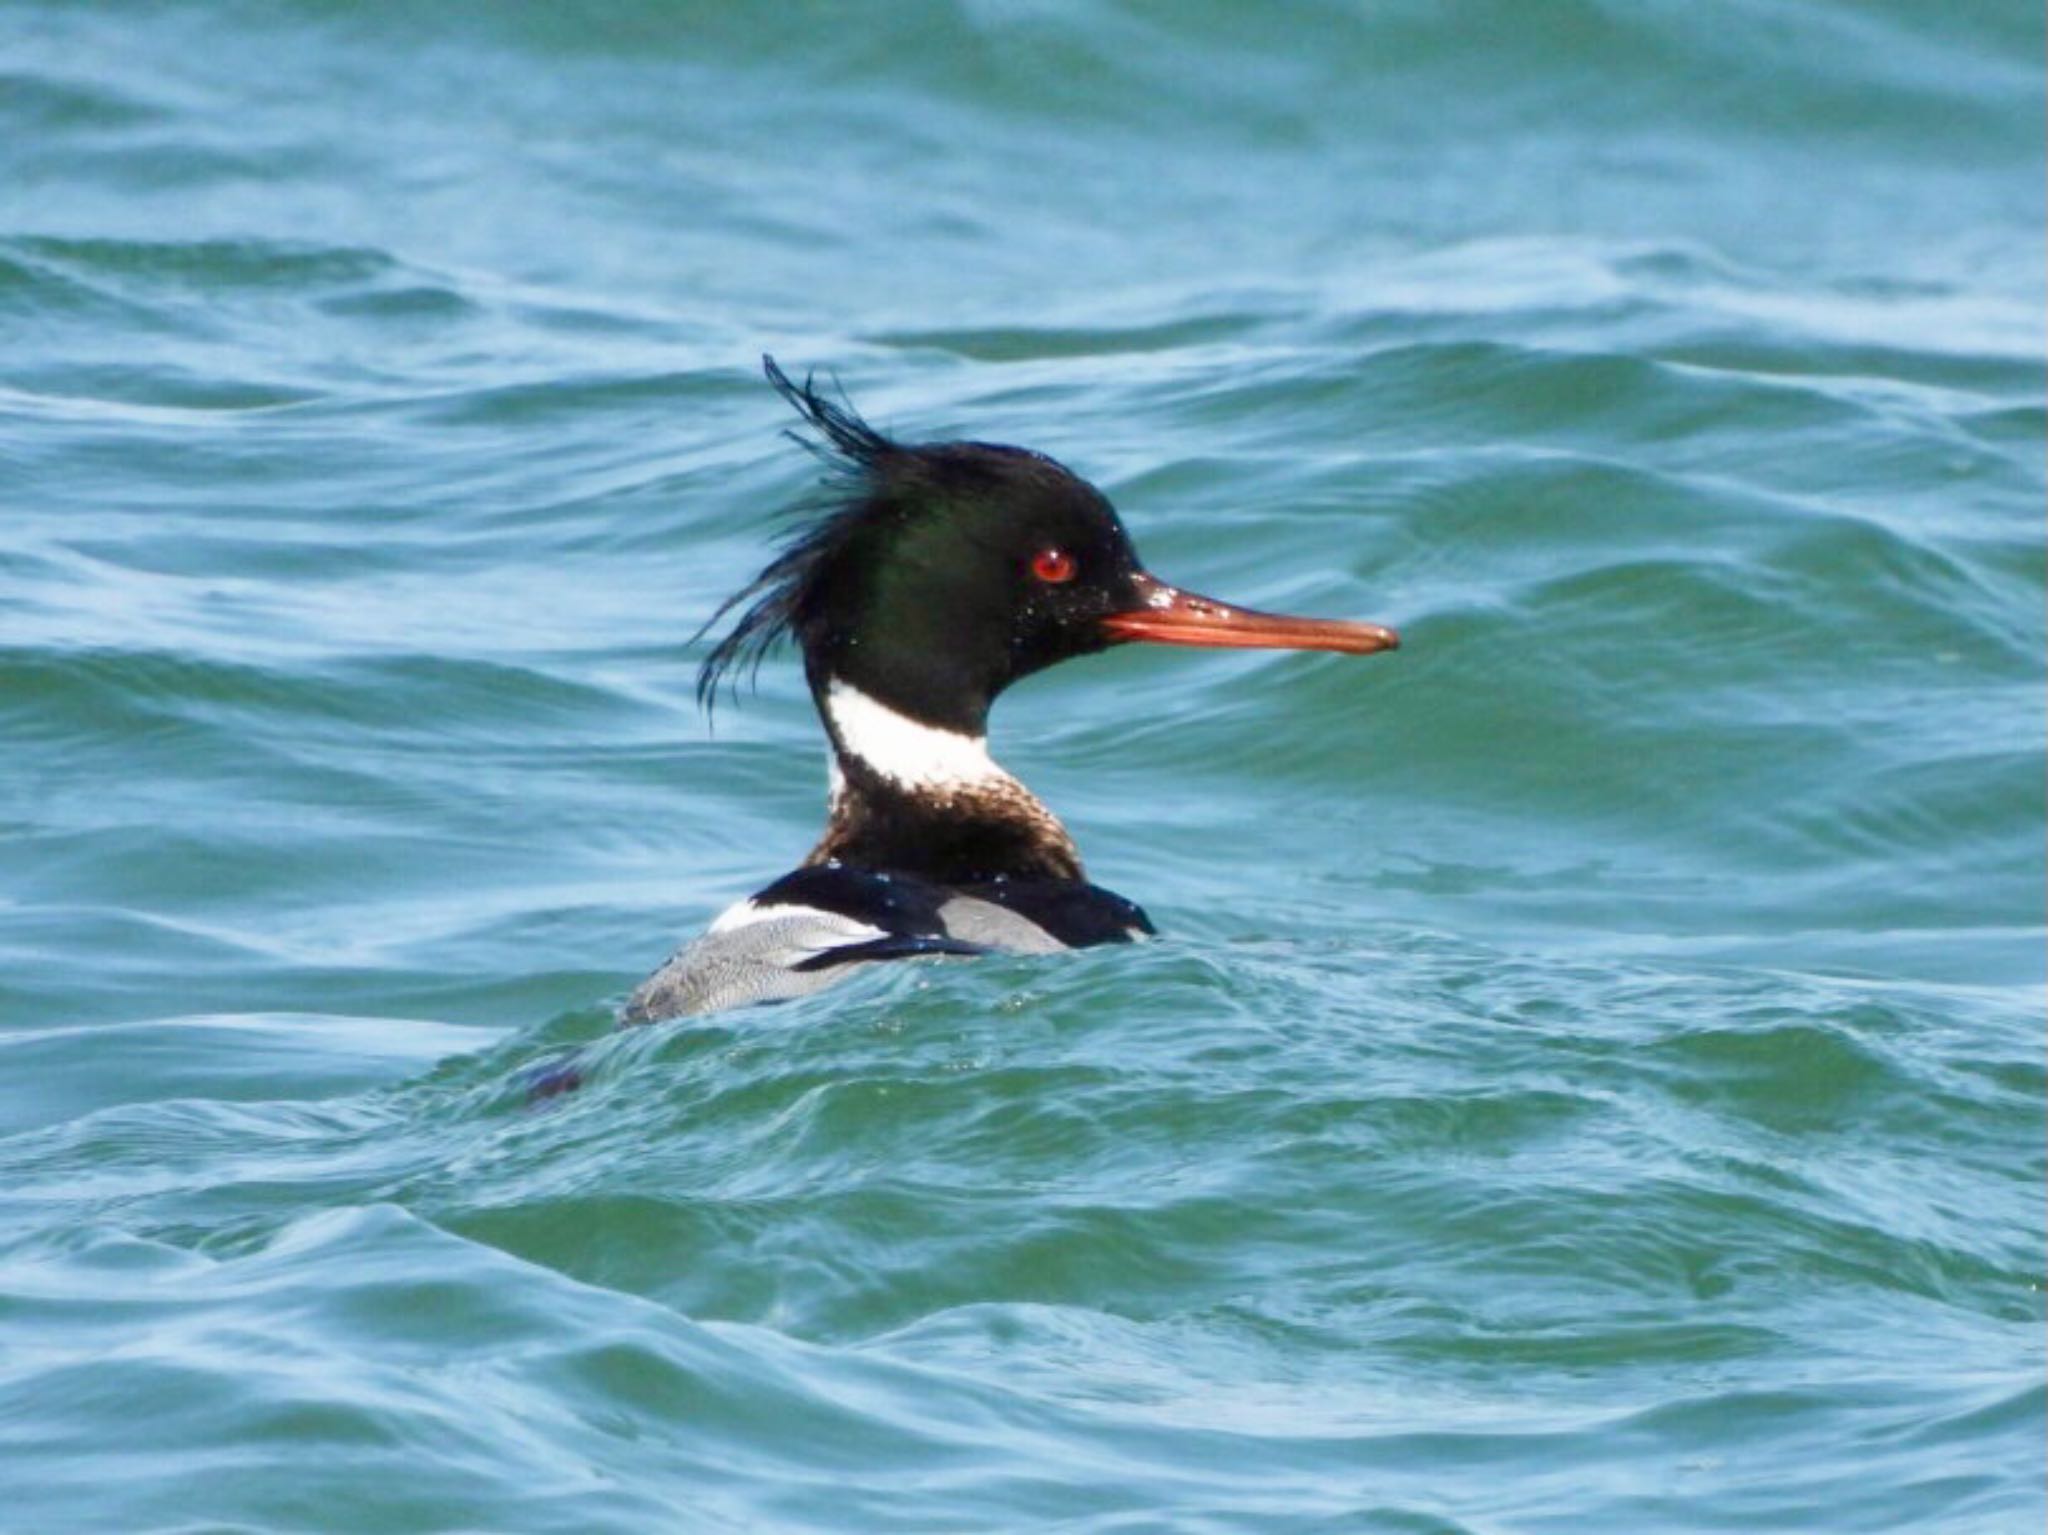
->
<box><xmin>696</xmin><ymin>358</ymin><xmax>1395</xmax><ymax>735</ymax></box>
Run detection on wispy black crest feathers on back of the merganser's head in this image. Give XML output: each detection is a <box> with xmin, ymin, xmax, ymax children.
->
<box><xmin>694</xmin><ymin>354</ymin><xmax>901</xmax><ymax>712</ymax></box>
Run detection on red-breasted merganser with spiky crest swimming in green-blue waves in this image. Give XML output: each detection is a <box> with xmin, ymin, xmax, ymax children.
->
<box><xmin>625</xmin><ymin>358</ymin><xmax>1399</xmax><ymax>1023</ymax></box>
